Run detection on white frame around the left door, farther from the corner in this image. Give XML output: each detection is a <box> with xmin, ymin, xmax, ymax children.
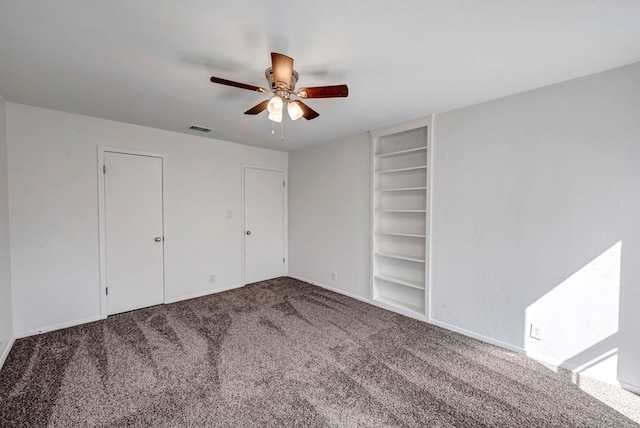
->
<box><xmin>96</xmin><ymin>146</ymin><xmax>167</xmax><ymax>319</ymax></box>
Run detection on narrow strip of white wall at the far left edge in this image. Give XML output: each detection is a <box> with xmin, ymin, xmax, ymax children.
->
<box><xmin>0</xmin><ymin>97</ymin><xmax>13</xmax><ymax>367</ymax></box>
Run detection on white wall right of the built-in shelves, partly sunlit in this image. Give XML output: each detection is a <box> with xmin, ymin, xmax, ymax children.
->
<box><xmin>431</xmin><ymin>64</ymin><xmax>640</xmax><ymax>388</ymax></box>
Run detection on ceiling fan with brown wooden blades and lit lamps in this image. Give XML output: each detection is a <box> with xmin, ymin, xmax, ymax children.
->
<box><xmin>211</xmin><ymin>52</ymin><xmax>349</xmax><ymax>122</ymax></box>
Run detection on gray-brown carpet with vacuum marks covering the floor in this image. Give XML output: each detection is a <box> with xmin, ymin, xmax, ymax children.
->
<box><xmin>0</xmin><ymin>278</ymin><xmax>638</xmax><ymax>427</ymax></box>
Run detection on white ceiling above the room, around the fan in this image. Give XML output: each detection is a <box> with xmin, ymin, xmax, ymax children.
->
<box><xmin>0</xmin><ymin>0</ymin><xmax>640</xmax><ymax>150</ymax></box>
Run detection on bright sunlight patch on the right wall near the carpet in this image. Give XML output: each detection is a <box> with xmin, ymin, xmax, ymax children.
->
<box><xmin>524</xmin><ymin>241</ymin><xmax>622</xmax><ymax>382</ymax></box>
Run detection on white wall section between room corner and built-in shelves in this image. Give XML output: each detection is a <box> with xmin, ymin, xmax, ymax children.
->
<box><xmin>289</xmin><ymin>133</ymin><xmax>371</xmax><ymax>299</ymax></box>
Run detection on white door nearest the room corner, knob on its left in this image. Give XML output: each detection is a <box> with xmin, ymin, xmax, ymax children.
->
<box><xmin>244</xmin><ymin>168</ymin><xmax>285</xmax><ymax>284</ymax></box>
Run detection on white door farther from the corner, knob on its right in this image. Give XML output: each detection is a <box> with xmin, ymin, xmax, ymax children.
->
<box><xmin>104</xmin><ymin>152</ymin><xmax>164</xmax><ymax>315</ymax></box>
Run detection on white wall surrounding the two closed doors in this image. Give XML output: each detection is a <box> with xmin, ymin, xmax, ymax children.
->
<box><xmin>7</xmin><ymin>103</ymin><xmax>288</xmax><ymax>336</ymax></box>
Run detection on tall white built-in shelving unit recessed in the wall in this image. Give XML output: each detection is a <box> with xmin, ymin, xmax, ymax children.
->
<box><xmin>371</xmin><ymin>120</ymin><xmax>430</xmax><ymax>319</ymax></box>
